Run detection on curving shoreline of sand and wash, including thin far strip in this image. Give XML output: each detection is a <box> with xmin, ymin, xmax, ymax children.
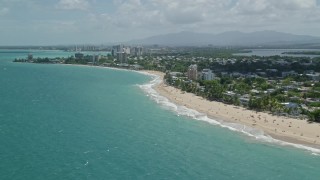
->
<box><xmin>18</xmin><ymin>61</ymin><xmax>320</xmax><ymax>151</ymax></box>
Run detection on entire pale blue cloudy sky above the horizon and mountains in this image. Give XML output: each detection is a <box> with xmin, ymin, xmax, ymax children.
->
<box><xmin>0</xmin><ymin>0</ymin><xmax>320</xmax><ymax>45</ymax></box>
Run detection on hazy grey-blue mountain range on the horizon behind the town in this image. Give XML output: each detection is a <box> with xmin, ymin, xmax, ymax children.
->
<box><xmin>129</xmin><ymin>31</ymin><xmax>320</xmax><ymax>46</ymax></box>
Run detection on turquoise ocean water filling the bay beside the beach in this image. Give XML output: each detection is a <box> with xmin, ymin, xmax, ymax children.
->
<box><xmin>0</xmin><ymin>50</ymin><xmax>320</xmax><ymax>180</ymax></box>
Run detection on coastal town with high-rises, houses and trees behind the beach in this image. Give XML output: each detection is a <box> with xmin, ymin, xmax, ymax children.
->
<box><xmin>15</xmin><ymin>45</ymin><xmax>320</xmax><ymax>122</ymax></box>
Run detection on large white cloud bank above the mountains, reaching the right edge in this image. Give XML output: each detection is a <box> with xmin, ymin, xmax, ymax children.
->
<box><xmin>87</xmin><ymin>0</ymin><xmax>320</xmax><ymax>37</ymax></box>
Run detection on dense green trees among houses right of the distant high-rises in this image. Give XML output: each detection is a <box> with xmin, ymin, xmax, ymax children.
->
<box><xmin>149</xmin><ymin>49</ymin><xmax>320</xmax><ymax>122</ymax></box>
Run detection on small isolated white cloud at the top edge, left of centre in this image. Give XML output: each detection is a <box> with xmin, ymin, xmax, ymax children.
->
<box><xmin>56</xmin><ymin>0</ymin><xmax>90</xmax><ymax>10</ymax></box>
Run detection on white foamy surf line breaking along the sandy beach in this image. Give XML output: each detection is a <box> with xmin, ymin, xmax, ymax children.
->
<box><xmin>138</xmin><ymin>72</ymin><xmax>320</xmax><ymax>155</ymax></box>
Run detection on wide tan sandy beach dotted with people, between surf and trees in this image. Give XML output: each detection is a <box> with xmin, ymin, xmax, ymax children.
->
<box><xmin>146</xmin><ymin>71</ymin><xmax>320</xmax><ymax>149</ymax></box>
